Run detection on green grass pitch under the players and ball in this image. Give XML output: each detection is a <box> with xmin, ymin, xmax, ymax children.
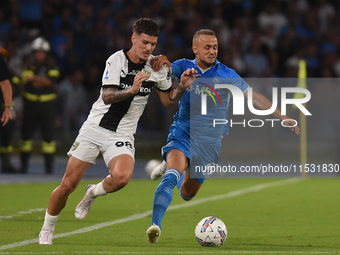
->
<box><xmin>0</xmin><ymin>178</ymin><xmax>340</xmax><ymax>254</ymax></box>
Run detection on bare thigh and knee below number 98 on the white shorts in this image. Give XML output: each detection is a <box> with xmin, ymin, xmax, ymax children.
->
<box><xmin>108</xmin><ymin>154</ymin><xmax>135</xmax><ymax>183</ymax></box>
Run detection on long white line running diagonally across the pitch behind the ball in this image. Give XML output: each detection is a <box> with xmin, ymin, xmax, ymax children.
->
<box><xmin>0</xmin><ymin>178</ymin><xmax>303</xmax><ymax>250</ymax></box>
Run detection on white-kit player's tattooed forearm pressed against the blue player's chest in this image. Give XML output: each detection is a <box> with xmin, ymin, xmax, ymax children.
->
<box><xmin>157</xmin><ymin>68</ymin><xmax>201</xmax><ymax>107</ymax></box>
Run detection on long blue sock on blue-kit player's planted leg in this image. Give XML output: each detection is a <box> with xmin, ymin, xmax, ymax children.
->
<box><xmin>151</xmin><ymin>169</ymin><xmax>181</xmax><ymax>228</ymax></box>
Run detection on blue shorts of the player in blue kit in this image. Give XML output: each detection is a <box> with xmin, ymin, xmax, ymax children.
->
<box><xmin>162</xmin><ymin>125</ymin><xmax>222</xmax><ymax>183</ymax></box>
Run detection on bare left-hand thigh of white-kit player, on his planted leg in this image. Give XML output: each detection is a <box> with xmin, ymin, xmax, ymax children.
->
<box><xmin>60</xmin><ymin>156</ymin><xmax>92</xmax><ymax>192</ymax></box>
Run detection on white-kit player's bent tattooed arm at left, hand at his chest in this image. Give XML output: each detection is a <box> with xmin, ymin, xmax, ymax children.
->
<box><xmin>102</xmin><ymin>72</ymin><xmax>149</xmax><ymax>104</ymax></box>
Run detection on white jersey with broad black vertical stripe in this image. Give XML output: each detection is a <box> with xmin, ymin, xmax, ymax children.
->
<box><xmin>86</xmin><ymin>50</ymin><xmax>172</xmax><ymax>135</ymax></box>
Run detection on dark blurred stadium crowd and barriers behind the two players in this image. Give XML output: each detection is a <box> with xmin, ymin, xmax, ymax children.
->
<box><xmin>0</xmin><ymin>0</ymin><xmax>340</xmax><ymax>176</ymax></box>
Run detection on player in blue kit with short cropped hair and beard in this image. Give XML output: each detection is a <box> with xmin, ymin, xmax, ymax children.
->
<box><xmin>146</xmin><ymin>29</ymin><xmax>300</xmax><ymax>243</ymax></box>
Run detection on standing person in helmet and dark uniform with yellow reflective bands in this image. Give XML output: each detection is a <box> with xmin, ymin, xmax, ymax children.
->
<box><xmin>21</xmin><ymin>37</ymin><xmax>60</xmax><ymax>174</ymax></box>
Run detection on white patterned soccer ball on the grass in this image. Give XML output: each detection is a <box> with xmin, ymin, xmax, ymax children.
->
<box><xmin>195</xmin><ymin>216</ymin><xmax>227</xmax><ymax>246</ymax></box>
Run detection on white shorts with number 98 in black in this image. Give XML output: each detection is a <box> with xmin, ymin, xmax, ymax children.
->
<box><xmin>67</xmin><ymin>122</ymin><xmax>135</xmax><ymax>166</ymax></box>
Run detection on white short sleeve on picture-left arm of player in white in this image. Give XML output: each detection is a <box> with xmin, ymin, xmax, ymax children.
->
<box><xmin>102</xmin><ymin>52</ymin><xmax>123</xmax><ymax>86</ymax></box>
